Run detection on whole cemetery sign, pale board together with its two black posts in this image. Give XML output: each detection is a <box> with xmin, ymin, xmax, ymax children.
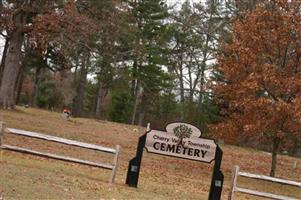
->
<box><xmin>126</xmin><ymin>122</ymin><xmax>224</xmax><ymax>200</ymax></box>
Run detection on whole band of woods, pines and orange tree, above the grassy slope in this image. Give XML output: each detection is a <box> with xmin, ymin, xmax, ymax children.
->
<box><xmin>0</xmin><ymin>0</ymin><xmax>301</xmax><ymax>175</ymax></box>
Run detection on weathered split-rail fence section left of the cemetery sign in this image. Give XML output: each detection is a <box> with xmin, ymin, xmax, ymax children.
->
<box><xmin>0</xmin><ymin>121</ymin><xmax>120</xmax><ymax>183</ymax></box>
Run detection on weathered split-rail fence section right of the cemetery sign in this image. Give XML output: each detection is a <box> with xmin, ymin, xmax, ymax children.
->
<box><xmin>228</xmin><ymin>166</ymin><xmax>301</xmax><ymax>200</ymax></box>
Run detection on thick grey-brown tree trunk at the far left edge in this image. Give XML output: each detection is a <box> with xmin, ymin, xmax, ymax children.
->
<box><xmin>0</xmin><ymin>13</ymin><xmax>26</xmax><ymax>109</ymax></box>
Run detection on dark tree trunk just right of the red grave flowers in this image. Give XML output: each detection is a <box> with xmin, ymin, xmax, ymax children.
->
<box><xmin>72</xmin><ymin>56</ymin><xmax>90</xmax><ymax>117</ymax></box>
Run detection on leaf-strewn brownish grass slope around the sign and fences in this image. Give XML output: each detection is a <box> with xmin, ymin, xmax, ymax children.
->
<box><xmin>0</xmin><ymin>107</ymin><xmax>301</xmax><ymax>199</ymax></box>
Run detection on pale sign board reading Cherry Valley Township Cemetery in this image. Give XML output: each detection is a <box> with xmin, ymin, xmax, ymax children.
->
<box><xmin>145</xmin><ymin>123</ymin><xmax>217</xmax><ymax>163</ymax></box>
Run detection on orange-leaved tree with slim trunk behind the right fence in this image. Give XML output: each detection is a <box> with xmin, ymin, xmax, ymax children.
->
<box><xmin>213</xmin><ymin>0</ymin><xmax>301</xmax><ymax>176</ymax></box>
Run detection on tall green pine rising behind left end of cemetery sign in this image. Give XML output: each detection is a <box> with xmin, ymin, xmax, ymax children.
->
<box><xmin>124</xmin><ymin>0</ymin><xmax>168</xmax><ymax>124</ymax></box>
